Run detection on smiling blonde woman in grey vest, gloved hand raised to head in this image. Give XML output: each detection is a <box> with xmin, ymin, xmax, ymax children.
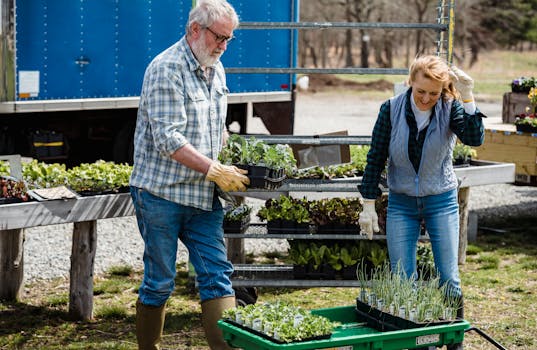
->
<box><xmin>359</xmin><ymin>56</ymin><xmax>485</xmax><ymax>349</ymax></box>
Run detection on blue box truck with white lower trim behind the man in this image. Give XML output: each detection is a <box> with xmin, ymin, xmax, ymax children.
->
<box><xmin>0</xmin><ymin>0</ymin><xmax>299</xmax><ymax>164</ymax></box>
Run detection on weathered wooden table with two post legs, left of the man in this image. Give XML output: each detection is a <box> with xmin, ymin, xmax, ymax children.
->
<box><xmin>0</xmin><ymin>193</ymin><xmax>134</xmax><ymax>320</ymax></box>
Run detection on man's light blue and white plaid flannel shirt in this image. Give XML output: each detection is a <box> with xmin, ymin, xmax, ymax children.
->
<box><xmin>130</xmin><ymin>37</ymin><xmax>228</xmax><ymax>210</ymax></box>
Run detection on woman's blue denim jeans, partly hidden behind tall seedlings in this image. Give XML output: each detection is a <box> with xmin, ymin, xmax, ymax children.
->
<box><xmin>386</xmin><ymin>190</ymin><xmax>462</xmax><ymax>297</ymax></box>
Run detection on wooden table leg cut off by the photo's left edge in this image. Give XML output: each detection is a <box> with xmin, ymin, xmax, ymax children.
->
<box><xmin>0</xmin><ymin>229</ymin><xmax>24</xmax><ymax>301</ymax></box>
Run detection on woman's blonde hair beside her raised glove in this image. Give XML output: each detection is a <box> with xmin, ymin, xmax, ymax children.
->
<box><xmin>408</xmin><ymin>55</ymin><xmax>459</xmax><ymax>100</ymax></box>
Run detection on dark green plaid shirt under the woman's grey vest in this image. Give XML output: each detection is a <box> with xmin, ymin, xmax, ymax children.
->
<box><xmin>360</xmin><ymin>89</ymin><xmax>486</xmax><ymax>199</ymax></box>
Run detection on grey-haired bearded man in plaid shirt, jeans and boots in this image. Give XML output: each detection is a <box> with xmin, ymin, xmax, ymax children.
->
<box><xmin>130</xmin><ymin>0</ymin><xmax>249</xmax><ymax>349</ymax></box>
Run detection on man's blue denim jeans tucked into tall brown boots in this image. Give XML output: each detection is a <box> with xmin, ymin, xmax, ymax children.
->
<box><xmin>130</xmin><ymin>186</ymin><xmax>234</xmax><ymax>306</ymax></box>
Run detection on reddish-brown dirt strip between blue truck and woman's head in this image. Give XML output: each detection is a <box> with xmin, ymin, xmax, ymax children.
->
<box><xmin>308</xmin><ymin>74</ymin><xmax>393</xmax><ymax>92</ymax></box>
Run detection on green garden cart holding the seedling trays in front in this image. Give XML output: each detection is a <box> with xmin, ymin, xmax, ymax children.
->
<box><xmin>218</xmin><ymin>306</ymin><xmax>470</xmax><ymax>350</ymax></box>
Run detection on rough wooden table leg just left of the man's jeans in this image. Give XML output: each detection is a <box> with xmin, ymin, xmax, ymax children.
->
<box><xmin>69</xmin><ymin>220</ymin><xmax>97</xmax><ymax>321</ymax></box>
